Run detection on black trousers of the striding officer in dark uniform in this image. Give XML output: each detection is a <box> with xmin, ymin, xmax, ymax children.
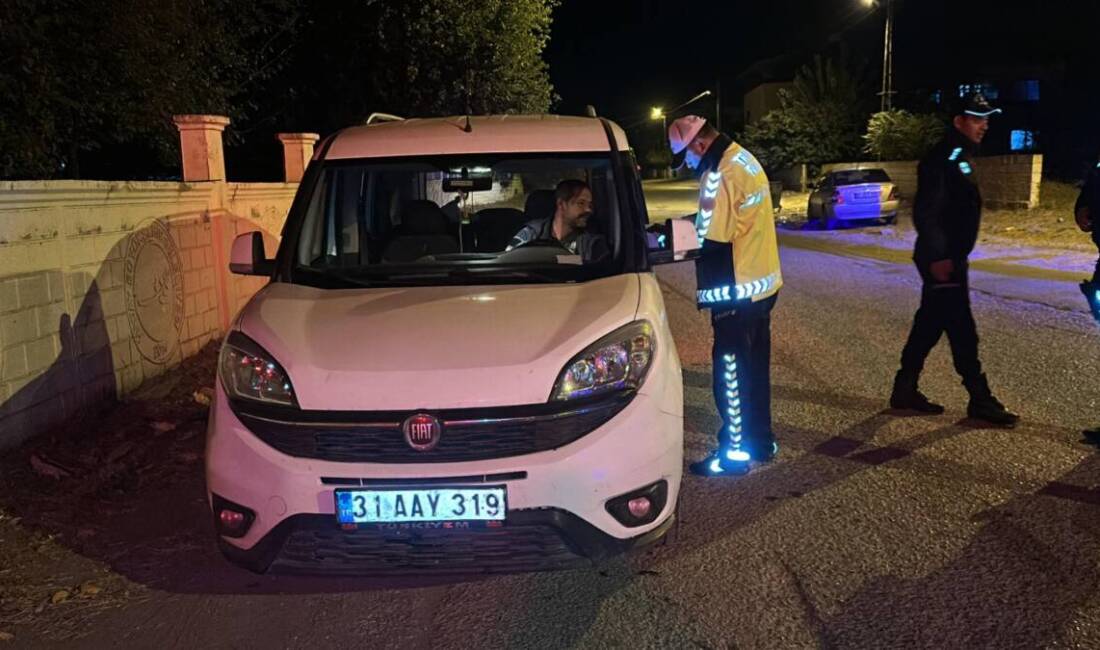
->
<box><xmin>901</xmin><ymin>261</ymin><xmax>981</xmax><ymax>382</ymax></box>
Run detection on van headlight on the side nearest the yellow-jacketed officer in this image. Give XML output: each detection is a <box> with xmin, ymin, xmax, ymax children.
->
<box><xmin>550</xmin><ymin>320</ymin><xmax>657</xmax><ymax>400</ymax></box>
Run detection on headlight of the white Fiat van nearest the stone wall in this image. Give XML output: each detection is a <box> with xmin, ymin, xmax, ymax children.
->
<box><xmin>218</xmin><ymin>332</ymin><xmax>298</xmax><ymax>407</ymax></box>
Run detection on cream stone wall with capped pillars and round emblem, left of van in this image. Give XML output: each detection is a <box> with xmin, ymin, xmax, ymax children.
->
<box><xmin>0</xmin><ymin>115</ymin><xmax>317</xmax><ymax>449</ymax></box>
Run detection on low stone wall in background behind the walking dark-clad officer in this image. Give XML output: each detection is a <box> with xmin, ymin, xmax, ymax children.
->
<box><xmin>822</xmin><ymin>154</ymin><xmax>1043</xmax><ymax>209</ymax></box>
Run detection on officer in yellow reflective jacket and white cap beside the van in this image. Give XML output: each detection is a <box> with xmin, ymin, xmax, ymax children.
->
<box><xmin>669</xmin><ymin>115</ymin><xmax>783</xmax><ymax>476</ymax></box>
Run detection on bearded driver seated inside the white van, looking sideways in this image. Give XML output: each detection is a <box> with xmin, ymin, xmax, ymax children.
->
<box><xmin>505</xmin><ymin>179</ymin><xmax>611</xmax><ymax>264</ymax></box>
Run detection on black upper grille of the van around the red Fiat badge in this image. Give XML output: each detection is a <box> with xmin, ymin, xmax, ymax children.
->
<box><xmin>234</xmin><ymin>395</ymin><xmax>631</xmax><ymax>463</ymax></box>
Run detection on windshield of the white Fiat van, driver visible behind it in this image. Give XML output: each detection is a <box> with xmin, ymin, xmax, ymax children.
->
<box><xmin>290</xmin><ymin>154</ymin><xmax>624</xmax><ymax>287</ymax></box>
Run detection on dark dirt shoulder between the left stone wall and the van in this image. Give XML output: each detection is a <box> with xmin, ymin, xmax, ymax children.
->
<box><xmin>0</xmin><ymin>343</ymin><xmax>219</xmax><ymax>646</ymax></box>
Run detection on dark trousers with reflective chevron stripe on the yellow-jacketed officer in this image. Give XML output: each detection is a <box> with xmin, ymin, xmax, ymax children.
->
<box><xmin>711</xmin><ymin>294</ymin><xmax>778</xmax><ymax>459</ymax></box>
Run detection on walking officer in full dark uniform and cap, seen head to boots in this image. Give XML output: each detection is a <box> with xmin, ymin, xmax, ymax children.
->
<box><xmin>890</xmin><ymin>93</ymin><xmax>1020</xmax><ymax>427</ymax></box>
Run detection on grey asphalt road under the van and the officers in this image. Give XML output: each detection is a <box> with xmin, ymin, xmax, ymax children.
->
<box><xmin>20</xmin><ymin>181</ymin><xmax>1100</xmax><ymax>648</ymax></box>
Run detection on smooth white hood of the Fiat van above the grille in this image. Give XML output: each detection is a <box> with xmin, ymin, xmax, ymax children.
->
<box><xmin>239</xmin><ymin>275</ymin><xmax>639</xmax><ymax>410</ymax></box>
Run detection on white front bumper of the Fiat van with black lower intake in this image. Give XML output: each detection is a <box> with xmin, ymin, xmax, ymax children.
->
<box><xmin>207</xmin><ymin>376</ymin><xmax>683</xmax><ymax>574</ymax></box>
